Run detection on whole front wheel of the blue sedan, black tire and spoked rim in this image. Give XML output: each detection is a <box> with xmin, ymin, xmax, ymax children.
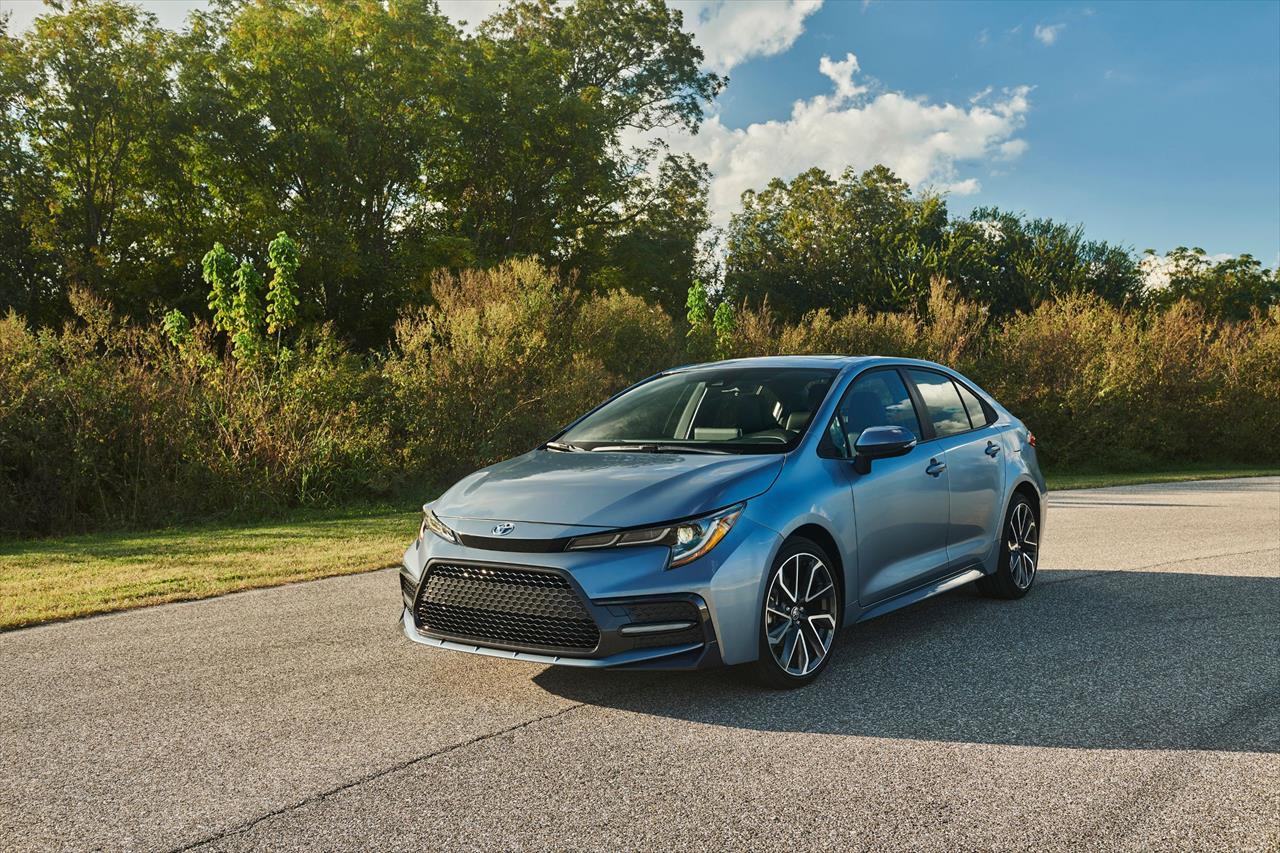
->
<box><xmin>753</xmin><ymin>537</ymin><xmax>844</xmax><ymax>690</ymax></box>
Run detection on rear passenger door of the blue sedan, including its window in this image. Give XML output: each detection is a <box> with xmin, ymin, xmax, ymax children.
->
<box><xmin>906</xmin><ymin>368</ymin><xmax>1005</xmax><ymax>567</ymax></box>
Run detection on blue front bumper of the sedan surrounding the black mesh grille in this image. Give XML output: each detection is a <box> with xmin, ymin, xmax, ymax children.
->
<box><xmin>401</xmin><ymin>519</ymin><xmax>780</xmax><ymax>669</ymax></box>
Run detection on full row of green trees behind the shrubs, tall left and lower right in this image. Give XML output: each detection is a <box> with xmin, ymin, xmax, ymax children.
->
<box><xmin>0</xmin><ymin>0</ymin><xmax>1280</xmax><ymax>350</ymax></box>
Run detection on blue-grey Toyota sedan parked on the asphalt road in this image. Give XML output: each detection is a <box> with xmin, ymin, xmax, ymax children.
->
<box><xmin>399</xmin><ymin>356</ymin><xmax>1046</xmax><ymax>688</ymax></box>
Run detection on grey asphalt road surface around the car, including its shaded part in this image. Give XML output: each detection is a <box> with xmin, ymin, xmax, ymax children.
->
<box><xmin>0</xmin><ymin>478</ymin><xmax>1280</xmax><ymax>850</ymax></box>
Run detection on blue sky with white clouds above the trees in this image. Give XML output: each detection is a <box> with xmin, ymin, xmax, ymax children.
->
<box><xmin>0</xmin><ymin>0</ymin><xmax>1280</xmax><ymax>266</ymax></box>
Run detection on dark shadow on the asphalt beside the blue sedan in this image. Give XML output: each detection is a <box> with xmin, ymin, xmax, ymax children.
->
<box><xmin>534</xmin><ymin>570</ymin><xmax>1280</xmax><ymax>753</ymax></box>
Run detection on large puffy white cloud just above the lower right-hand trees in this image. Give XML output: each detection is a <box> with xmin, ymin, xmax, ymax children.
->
<box><xmin>667</xmin><ymin>54</ymin><xmax>1030</xmax><ymax>225</ymax></box>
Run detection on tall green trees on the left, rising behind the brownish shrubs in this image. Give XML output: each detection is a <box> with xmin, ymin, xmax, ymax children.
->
<box><xmin>0</xmin><ymin>0</ymin><xmax>722</xmax><ymax>347</ymax></box>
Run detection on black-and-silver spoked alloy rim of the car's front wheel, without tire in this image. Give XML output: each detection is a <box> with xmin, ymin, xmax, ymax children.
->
<box><xmin>764</xmin><ymin>553</ymin><xmax>840</xmax><ymax>678</ymax></box>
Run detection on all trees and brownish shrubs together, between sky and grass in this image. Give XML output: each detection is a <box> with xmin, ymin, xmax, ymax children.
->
<box><xmin>0</xmin><ymin>0</ymin><xmax>1280</xmax><ymax>534</ymax></box>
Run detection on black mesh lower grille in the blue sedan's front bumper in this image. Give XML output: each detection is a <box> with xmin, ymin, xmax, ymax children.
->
<box><xmin>415</xmin><ymin>565</ymin><xmax>600</xmax><ymax>652</ymax></box>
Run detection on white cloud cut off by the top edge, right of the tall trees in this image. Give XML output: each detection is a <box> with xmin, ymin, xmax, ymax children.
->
<box><xmin>668</xmin><ymin>0</ymin><xmax>822</xmax><ymax>73</ymax></box>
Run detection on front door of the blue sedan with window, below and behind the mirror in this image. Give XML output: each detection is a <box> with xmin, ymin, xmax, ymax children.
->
<box><xmin>828</xmin><ymin>368</ymin><xmax>948</xmax><ymax>607</ymax></box>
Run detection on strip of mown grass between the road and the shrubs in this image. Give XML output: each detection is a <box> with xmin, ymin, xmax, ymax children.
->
<box><xmin>0</xmin><ymin>465</ymin><xmax>1280</xmax><ymax>631</ymax></box>
